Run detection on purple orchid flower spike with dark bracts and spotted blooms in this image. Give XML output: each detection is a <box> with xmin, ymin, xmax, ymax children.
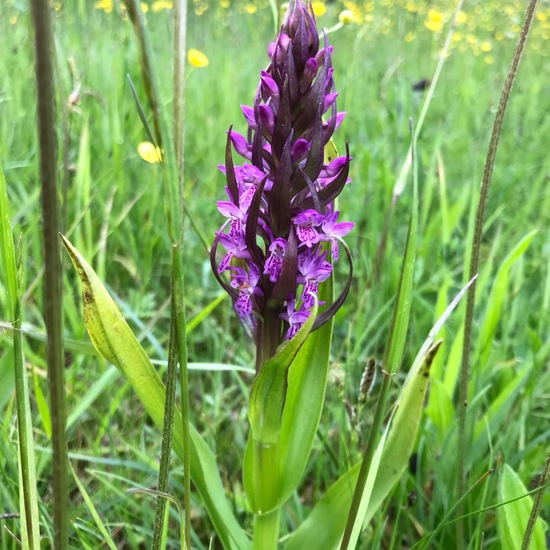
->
<box><xmin>211</xmin><ymin>0</ymin><xmax>354</xmax><ymax>370</ymax></box>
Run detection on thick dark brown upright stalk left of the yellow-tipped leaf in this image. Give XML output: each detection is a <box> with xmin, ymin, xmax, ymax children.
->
<box><xmin>31</xmin><ymin>0</ymin><xmax>69</xmax><ymax>550</ymax></box>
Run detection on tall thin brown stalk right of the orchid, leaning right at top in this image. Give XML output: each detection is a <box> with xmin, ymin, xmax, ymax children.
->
<box><xmin>457</xmin><ymin>0</ymin><xmax>537</xmax><ymax>550</ymax></box>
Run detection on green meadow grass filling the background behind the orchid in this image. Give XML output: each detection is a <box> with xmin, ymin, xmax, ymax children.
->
<box><xmin>0</xmin><ymin>2</ymin><xmax>550</xmax><ymax>549</ymax></box>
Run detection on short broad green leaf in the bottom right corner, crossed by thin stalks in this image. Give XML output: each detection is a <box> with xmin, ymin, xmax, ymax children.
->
<box><xmin>497</xmin><ymin>464</ymin><xmax>546</xmax><ymax>550</ymax></box>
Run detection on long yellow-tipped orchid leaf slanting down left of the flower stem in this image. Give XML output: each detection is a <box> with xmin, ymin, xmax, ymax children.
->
<box><xmin>62</xmin><ymin>236</ymin><xmax>250</xmax><ymax>549</ymax></box>
